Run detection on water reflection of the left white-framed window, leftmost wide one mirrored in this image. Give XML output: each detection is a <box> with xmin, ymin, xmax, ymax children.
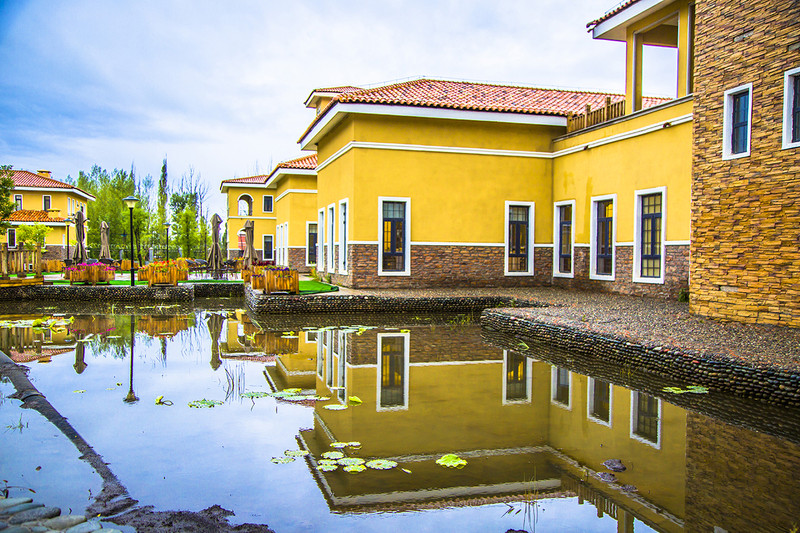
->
<box><xmin>376</xmin><ymin>333</ymin><xmax>411</xmax><ymax>411</ymax></box>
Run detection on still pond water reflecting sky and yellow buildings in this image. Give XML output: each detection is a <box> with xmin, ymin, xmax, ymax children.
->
<box><xmin>0</xmin><ymin>300</ymin><xmax>800</xmax><ymax>532</ymax></box>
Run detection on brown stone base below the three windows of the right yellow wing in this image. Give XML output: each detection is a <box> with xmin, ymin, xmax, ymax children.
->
<box><xmin>553</xmin><ymin>245</ymin><xmax>689</xmax><ymax>300</ymax></box>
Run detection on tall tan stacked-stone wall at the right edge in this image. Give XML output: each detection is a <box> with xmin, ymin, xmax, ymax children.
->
<box><xmin>691</xmin><ymin>0</ymin><xmax>800</xmax><ymax>327</ymax></box>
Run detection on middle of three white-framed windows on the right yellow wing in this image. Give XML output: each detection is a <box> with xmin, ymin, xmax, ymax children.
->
<box><xmin>589</xmin><ymin>194</ymin><xmax>617</xmax><ymax>281</ymax></box>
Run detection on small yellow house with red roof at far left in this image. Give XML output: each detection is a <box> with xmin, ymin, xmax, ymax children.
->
<box><xmin>0</xmin><ymin>170</ymin><xmax>95</xmax><ymax>259</ymax></box>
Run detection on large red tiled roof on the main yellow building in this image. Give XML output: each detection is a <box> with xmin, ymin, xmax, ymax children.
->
<box><xmin>303</xmin><ymin>79</ymin><xmax>669</xmax><ymax>142</ymax></box>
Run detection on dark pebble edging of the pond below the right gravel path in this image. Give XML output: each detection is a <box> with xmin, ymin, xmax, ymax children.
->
<box><xmin>481</xmin><ymin>309</ymin><xmax>800</xmax><ymax>407</ymax></box>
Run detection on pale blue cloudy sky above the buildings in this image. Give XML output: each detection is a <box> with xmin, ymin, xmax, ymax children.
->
<box><xmin>0</xmin><ymin>0</ymin><xmax>675</xmax><ymax>218</ymax></box>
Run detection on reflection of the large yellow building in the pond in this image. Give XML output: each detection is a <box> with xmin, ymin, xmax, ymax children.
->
<box><xmin>300</xmin><ymin>327</ymin><xmax>686</xmax><ymax>531</ymax></box>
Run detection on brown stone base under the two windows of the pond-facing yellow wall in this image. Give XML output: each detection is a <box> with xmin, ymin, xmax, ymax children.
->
<box><xmin>333</xmin><ymin>244</ymin><xmax>553</xmax><ymax>289</ymax></box>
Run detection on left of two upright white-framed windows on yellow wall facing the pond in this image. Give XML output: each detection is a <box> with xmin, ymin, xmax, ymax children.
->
<box><xmin>378</xmin><ymin>196</ymin><xmax>411</xmax><ymax>276</ymax></box>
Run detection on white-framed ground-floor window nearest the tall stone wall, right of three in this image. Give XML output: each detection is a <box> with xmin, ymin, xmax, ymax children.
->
<box><xmin>633</xmin><ymin>187</ymin><xmax>667</xmax><ymax>283</ymax></box>
